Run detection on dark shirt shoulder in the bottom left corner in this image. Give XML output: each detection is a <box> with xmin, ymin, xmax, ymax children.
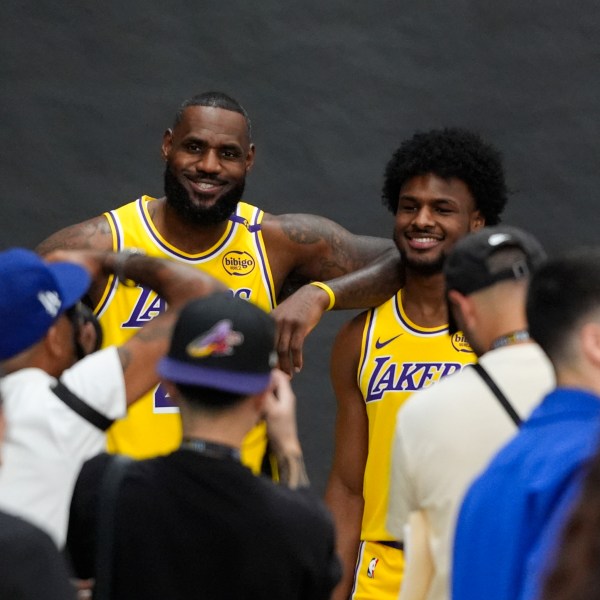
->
<box><xmin>0</xmin><ymin>512</ymin><xmax>75</xmax><ymax>600</ymax></box>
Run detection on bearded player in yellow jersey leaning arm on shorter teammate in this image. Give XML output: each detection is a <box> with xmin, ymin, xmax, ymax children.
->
<box><xmin>38</xmin><ymin>92</ymin><xmax>401</xmax><ymax>471</ymax></box>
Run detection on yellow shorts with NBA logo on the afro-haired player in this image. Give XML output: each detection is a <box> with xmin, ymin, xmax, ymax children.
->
<box><xmin>350</xmin><ymin>542</ymin><xmax>404</xmax><ymax>600</ymax></box>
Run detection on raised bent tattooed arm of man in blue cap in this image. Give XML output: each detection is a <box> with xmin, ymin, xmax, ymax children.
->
<box><xmin>42</xmin><ymin>250</ymin><xmax>225</xmax><ymax>405</ymax></box>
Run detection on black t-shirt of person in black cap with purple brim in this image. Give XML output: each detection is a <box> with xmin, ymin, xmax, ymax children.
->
<box><xmin>67</xmin><ymin>450</ymin><xmax>340</xmax><ymax>600</ymax></box>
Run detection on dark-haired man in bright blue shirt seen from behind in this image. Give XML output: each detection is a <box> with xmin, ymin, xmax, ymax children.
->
<box><xmin>452</xmin><ymin>248</ymin><xmax>600</xmax><ymax>600</ymax></box>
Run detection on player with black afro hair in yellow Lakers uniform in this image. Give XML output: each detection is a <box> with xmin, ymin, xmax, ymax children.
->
<box><xmin>326</xmin><ymin>129</ymin><xmax>506</xmax><ymax>600</ymax></box>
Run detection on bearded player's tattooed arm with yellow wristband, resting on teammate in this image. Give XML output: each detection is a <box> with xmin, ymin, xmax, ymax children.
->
<box><xmin>263</xmin><ymin>214</ymin><xmax>403</xmax><ymax>373</ymax></box>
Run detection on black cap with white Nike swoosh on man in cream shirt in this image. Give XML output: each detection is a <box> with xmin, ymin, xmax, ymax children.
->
<box><xmin>444</xmin><ymin>225</ymin><xmax>546</xmax><ymax>295</ymax></box>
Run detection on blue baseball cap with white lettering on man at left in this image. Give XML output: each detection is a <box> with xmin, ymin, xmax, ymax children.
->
<box><xmin>0</xmin><ymin>248</ymin><xmax>91</xmax><ymax>360</ymax></box>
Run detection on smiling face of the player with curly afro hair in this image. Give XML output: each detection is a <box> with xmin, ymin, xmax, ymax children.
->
<box><xmin>394</xmin><ymin>173</ymin><xmax>484</xmax><ymax>274</ymax></box>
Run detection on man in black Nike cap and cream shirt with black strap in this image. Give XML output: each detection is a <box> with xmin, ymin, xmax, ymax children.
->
<box><xmin>387</xmin><ymin>226</ymin><xmax>554</xmax><ymax>600</ymax></box>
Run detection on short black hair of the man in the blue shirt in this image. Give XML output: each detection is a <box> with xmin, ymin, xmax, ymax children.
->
<box><xmin>526</xmin><ymin>247</ymin><xmax>600</xmax><ymax>365</ymax></box>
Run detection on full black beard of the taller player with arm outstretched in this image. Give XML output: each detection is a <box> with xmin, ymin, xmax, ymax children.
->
<box><xmin>164</xmin><ymin>165</ymin><xmax>246</xmax><ymax>225</ymax></box>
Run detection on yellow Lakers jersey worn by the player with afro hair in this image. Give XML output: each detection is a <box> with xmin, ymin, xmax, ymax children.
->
<box><xmin>358</xmin><ymin>291</ymin><xmax>475</xmax><ymax>541</ymax></box>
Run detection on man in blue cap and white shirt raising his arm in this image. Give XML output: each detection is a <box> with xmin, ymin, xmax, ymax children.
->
<box><xmin>0</xmin><ymin>248</ymin><xmax>222</xmax><ymax>548</ymax></box>
